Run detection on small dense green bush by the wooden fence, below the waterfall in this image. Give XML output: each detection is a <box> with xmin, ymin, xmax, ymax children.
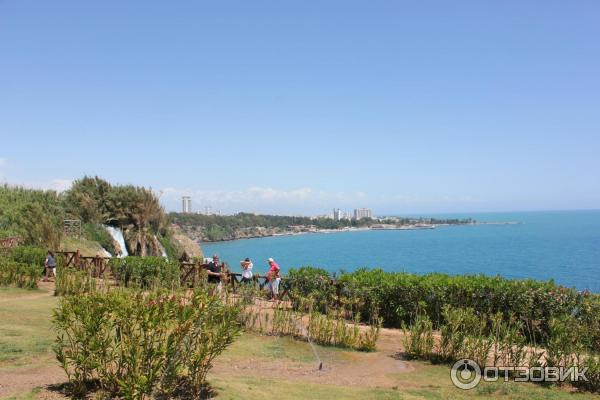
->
<box><xmin>109</xmin><ymin>256</ymin><xmax>180</xmax><ymax>289</ymax></box>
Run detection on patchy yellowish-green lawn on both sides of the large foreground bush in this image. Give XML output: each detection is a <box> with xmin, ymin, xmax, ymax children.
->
<box><xmin>0</xmin><ymin>288</ymin><xmax>600</xmax><ymax>400</ymax></box>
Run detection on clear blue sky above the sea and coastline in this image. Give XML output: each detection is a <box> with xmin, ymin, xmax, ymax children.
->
<box><xmin>0</xmin><ymin>0</ymin><xmax>600</xmax><ymax>214</ymax></box>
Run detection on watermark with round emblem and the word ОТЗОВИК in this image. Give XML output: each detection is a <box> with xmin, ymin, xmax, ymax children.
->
<box><xmin>450</xmin><ymin>358</ymin><xmax>588</xmax><ymax>390</ymax></box>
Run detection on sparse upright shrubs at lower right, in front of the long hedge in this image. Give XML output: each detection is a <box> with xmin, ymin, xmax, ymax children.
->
<box><xmin>402</xmin><ymin>306</ymin><xmax>600</xmax><ymax>392</ymax></box>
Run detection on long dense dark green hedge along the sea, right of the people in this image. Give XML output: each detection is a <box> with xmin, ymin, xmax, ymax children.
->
<box><xmin>290</xmin><ymin>267</ymin><xmax>600</xmax><ymax>348</ymax></box>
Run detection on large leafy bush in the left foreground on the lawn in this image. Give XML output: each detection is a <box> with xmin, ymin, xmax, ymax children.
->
<box><xmin>53</xmin><ymin>289</ymin><xmax>240</xmax><ymax>399</ymax></box>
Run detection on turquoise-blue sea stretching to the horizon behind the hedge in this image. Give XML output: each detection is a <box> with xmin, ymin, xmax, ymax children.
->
<box><xmin>202</xmin><ymin>210</ymin><xmax>600</xmax><ymax>293</ymax></box>
